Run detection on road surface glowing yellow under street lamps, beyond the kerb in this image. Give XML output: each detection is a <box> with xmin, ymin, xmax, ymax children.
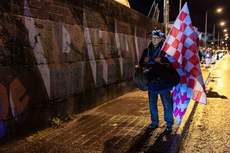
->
<box><xmin>180</xmin><ymin>55</ymin><xmax>230</xmax><ymax>153</ymax></box>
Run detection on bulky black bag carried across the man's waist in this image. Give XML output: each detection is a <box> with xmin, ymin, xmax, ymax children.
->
<box><xmin>133</xmin><ymin>63</ymin><xmax>180</xmax><ymax>94</ymax></box>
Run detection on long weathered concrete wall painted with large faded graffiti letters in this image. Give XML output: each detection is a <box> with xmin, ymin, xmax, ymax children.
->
<box><xmin>0</xmin><ymin>0</ymin><xmax>162</xmax><ymax>137</ymax></box>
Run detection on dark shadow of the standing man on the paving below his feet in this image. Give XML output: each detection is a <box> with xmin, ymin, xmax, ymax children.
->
<box><xmin>103</xmin><ymin>129</ymin><xmax>180</xmax><ymax>153</ymax></box>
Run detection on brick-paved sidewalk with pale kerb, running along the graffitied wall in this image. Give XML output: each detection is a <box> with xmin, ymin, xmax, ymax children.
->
<box><xmin>0</xmin><ymin>68</ymin><xmax>210</xmax><ymax>153</ymax></box>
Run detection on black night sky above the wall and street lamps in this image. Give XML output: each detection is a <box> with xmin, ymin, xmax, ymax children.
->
<box><xmin>129</xmin><ymin>0</ymin><xmax>230</xmax><ymax>41</ymax></box>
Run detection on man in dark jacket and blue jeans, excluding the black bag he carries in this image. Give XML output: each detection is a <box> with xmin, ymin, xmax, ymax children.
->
<box><xmin>139</xmin><ymin>30</ymin><xmax>174</xmax><ymax>132</ymax></box>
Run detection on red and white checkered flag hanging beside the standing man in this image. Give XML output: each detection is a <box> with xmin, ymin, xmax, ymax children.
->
<box><xmin>162</xmin><ymin>3</ymin><xmax>207</xmax><ymax>124</ymax></box>
